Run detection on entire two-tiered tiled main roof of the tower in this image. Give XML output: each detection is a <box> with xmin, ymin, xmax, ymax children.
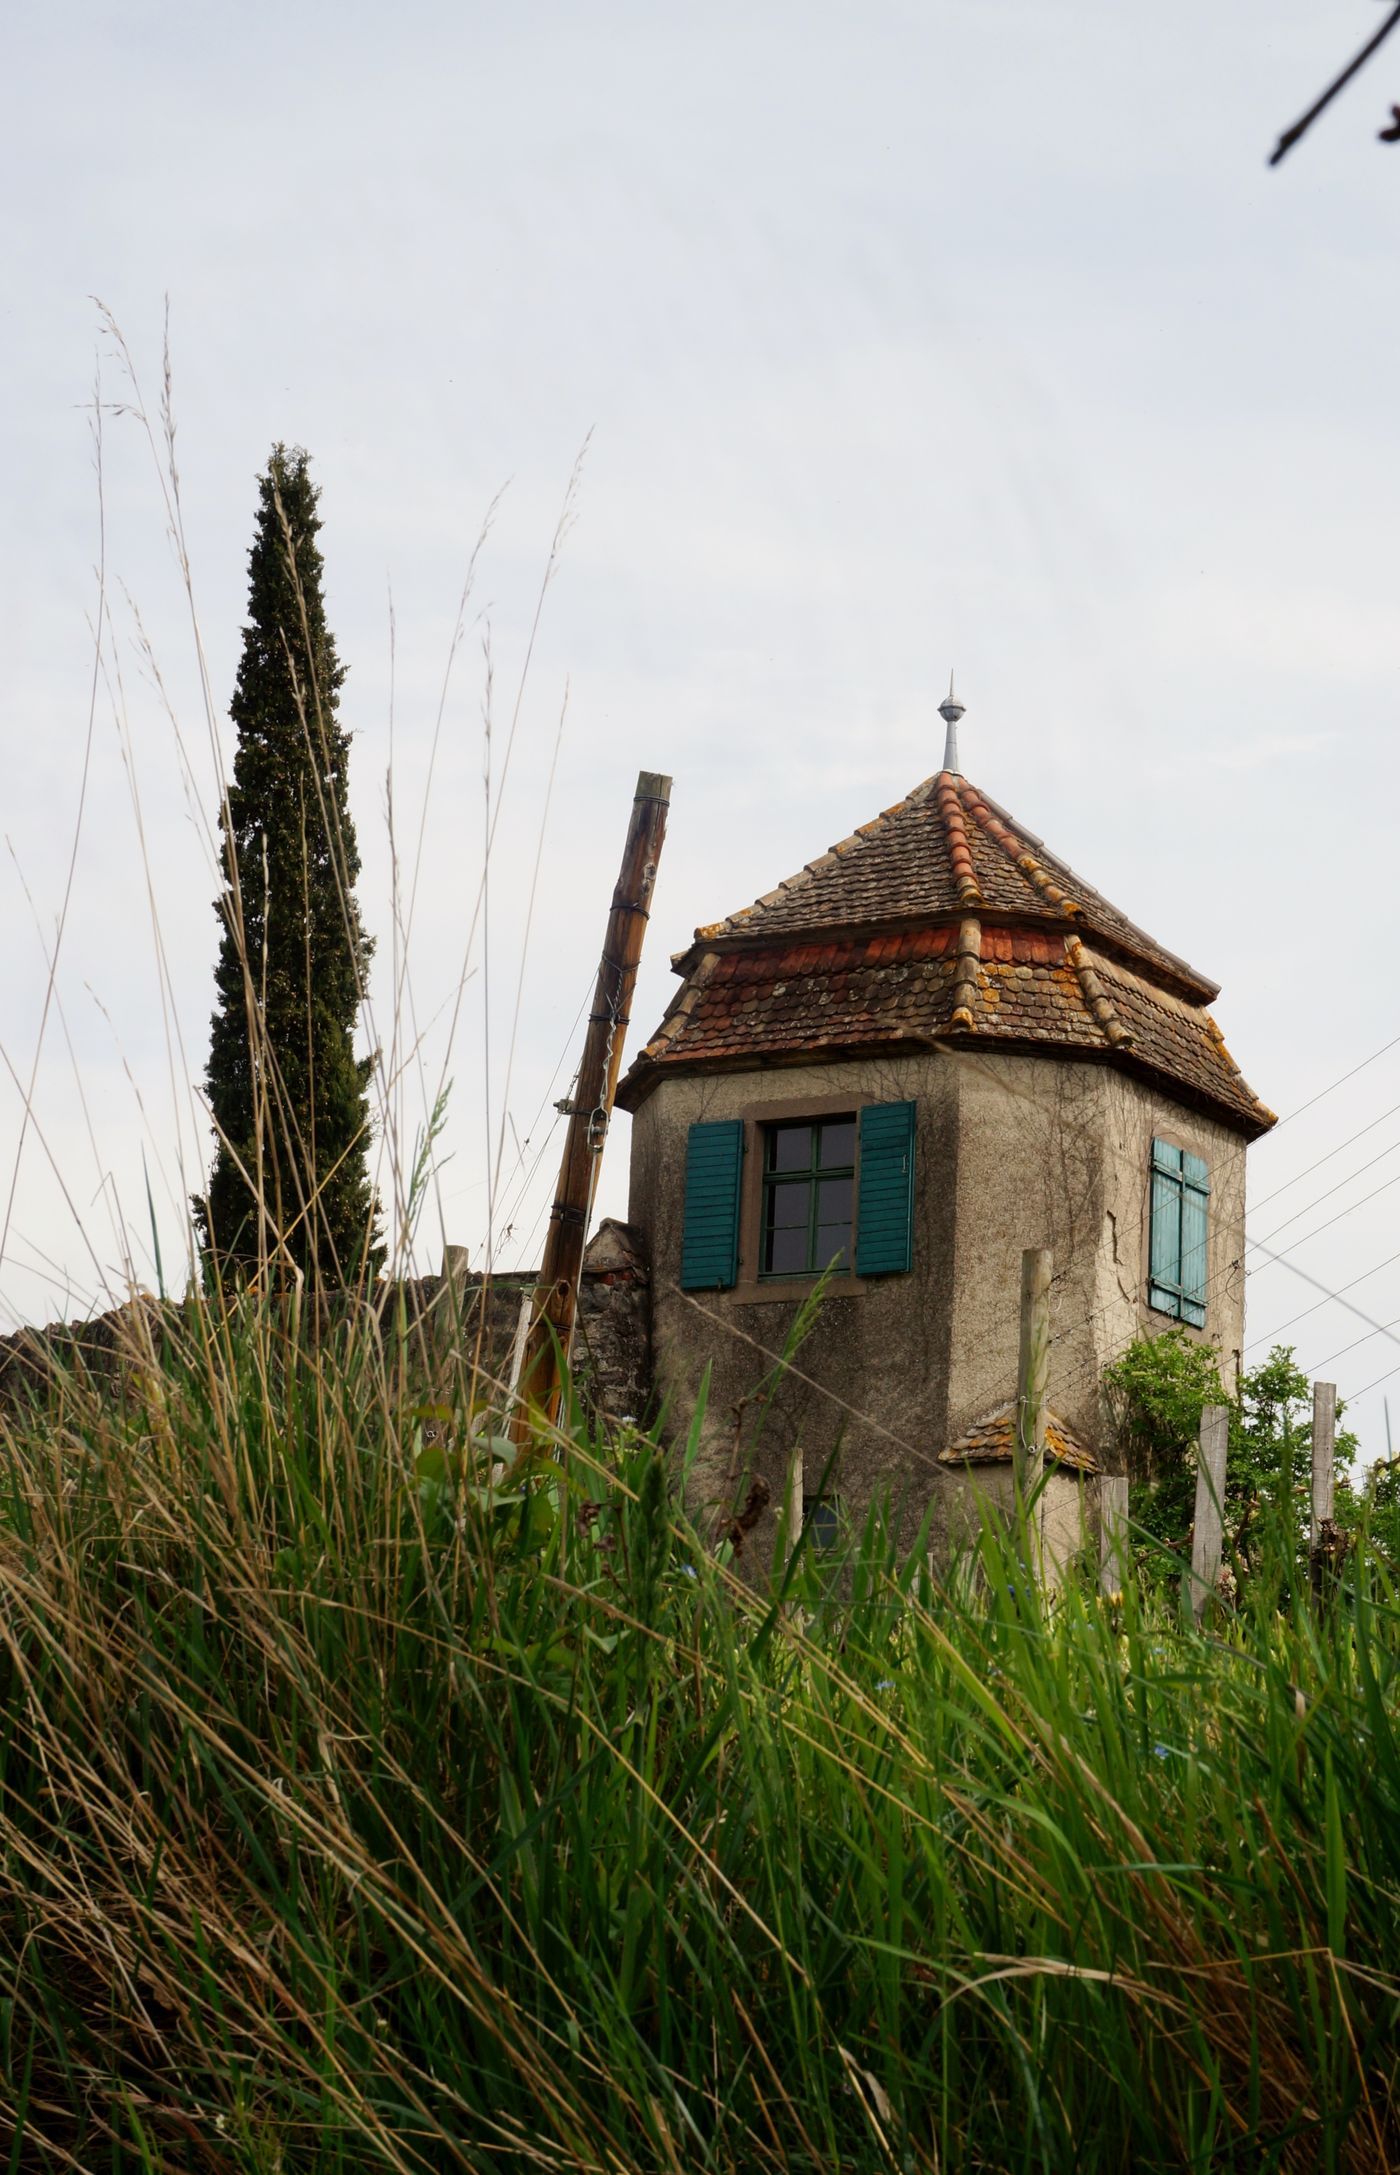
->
<box><xmin>620</xmin><ymin>772</ymin><xmax>1274</xmax><ymax>1138</ymax></box>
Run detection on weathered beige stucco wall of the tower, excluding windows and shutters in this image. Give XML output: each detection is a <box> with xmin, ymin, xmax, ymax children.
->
<box><xmin>630</xmin><ymin>1048</ymin><xmax>1243</xmax><ymax>1555</ymax></box>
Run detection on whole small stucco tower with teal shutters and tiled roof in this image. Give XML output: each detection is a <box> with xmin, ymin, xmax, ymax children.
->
<box><xmin>617</xmin><ymin>735</ymin><xmax>1274</xmax><ymax>1551</ymax></box>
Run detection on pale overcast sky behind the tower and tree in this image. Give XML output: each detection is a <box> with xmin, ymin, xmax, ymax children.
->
<box><xmin>0</xmin><ymin>0</ymin><xmax>1400</xmax><ymax>1457</ymax></box>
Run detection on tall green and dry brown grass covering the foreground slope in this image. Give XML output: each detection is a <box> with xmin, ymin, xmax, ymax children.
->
<box><xmin>0</xmin><ymin>1294</ymin><xmax>1400</xmax><ymax>2175</ymax></box>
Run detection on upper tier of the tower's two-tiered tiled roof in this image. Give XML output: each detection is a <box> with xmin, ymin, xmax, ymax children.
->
<box><xmin>696</xmin><ymin>770</ymin><xmax>1220</xmax><ymax>1003</ymax></box>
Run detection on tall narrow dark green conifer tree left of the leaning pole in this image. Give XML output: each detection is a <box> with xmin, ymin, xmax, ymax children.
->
<box><xmin>193</xmin><ymin>446</ymin><xmax>380</xmax><ymax>1285</ymax></box>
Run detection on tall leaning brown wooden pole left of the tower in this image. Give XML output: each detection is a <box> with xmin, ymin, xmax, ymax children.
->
<box><xmin>511</xmin><ymin>770</ymin><xmax>672</xmax><ymax>1442</ymax></box>
